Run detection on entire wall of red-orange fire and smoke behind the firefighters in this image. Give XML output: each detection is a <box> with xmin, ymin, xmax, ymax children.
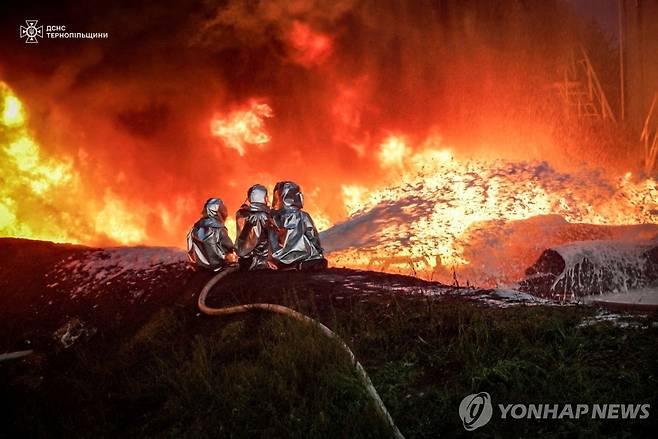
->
<box><xmin>0</xmin><ymin>0</ymin><xmax>658</xmax><ymax>286</ymax></box>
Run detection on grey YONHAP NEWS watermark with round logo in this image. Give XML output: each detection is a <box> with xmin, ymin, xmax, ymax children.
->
<box><xmin>459</xmin><ymin>392</ymin><xmax>651</xmax><ymax>431</ymax></box>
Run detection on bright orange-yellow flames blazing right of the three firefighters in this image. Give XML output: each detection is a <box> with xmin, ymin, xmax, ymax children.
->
<box><xmin>328</xmin><ymin>137</ymin><xmax>658</xmax><ymax>282</ymax></box>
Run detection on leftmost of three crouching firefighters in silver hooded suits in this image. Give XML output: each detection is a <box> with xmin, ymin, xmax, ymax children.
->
<box><xmin>187</xmin><ymin>198</ymin><xmax>237</xmax><ymax>271</ymax></box>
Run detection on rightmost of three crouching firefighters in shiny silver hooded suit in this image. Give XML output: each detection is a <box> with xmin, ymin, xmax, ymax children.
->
<box><xmin>270</xmin><ymin>181</ymin><xmax>327</xmax><ymax>270</ymax></box>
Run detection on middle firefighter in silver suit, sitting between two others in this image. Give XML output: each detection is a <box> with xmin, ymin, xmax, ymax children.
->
<box><xmin>235</xmin><ymin>184</ymin><xmax>274</xmax><ymax>270</ymax></box>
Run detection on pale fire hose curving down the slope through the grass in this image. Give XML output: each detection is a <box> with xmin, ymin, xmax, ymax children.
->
<box><xmin>198</xmin><ymin>267</ymin><xmax>404</xmax><ymax>439</ymax></box>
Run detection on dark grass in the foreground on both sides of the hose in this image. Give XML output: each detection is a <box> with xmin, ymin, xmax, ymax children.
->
<box><xmin>0</xmin><ymin>291</ymin><xmax>658</xmax><ymax>438</ymax></box>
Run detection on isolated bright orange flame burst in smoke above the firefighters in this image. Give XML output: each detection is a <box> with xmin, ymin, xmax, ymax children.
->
<box><xmin>210</xmin><ymin>101</ymin><xmax>274</xmax><ymax>156</ymax></box>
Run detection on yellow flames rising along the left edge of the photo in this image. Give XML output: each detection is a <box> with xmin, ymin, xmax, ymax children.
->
<box><xmin>0</xmin><ymin>82</ymin><xmax>146</xmax><ymax>248</ymax></box>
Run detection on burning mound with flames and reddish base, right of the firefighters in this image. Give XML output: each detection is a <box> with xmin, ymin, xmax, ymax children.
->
<box><xmin>322</xmin><ymin>146</ymin><xmax>658</xmax><ymax>286</ymax></box>
